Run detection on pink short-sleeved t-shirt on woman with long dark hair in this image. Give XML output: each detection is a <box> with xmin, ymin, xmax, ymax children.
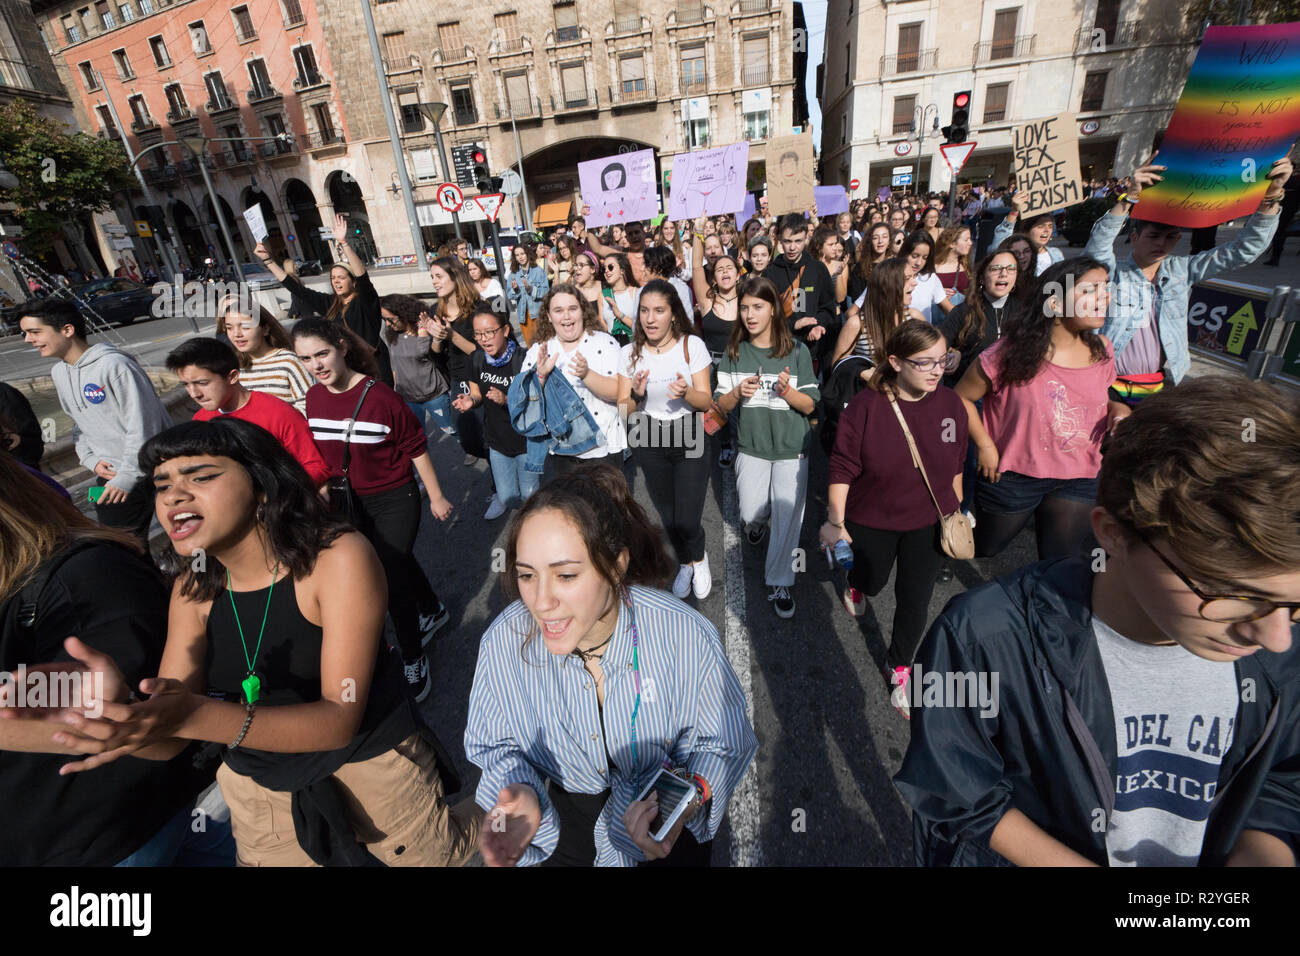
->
<box><xmin>979</xmin><ymin>338</ymin><xmax>1115</xmax><ymax>479</ymax></box>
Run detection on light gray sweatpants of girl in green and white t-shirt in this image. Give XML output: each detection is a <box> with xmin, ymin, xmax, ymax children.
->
<box><xmin>736</xmin><ymin>451</ymin><xmax>809</xmax><ymax>588</ymax></box>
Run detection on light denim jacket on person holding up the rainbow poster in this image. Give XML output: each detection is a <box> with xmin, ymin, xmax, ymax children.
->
<box><xmin>1084</xmin><ymin>212</ymin><xmax>1278</xmax><ymax>382</ymax></box>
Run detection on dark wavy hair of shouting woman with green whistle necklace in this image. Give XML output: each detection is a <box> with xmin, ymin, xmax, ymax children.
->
<box><xmin>139</xmin><ymin>415</ymin><xmax>351</xmax><ymax>601</ymax></box>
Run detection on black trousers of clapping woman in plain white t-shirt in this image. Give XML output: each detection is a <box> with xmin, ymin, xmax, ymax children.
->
<box><xmin>632</xmin><ymin>416</ymin><xmax>710</xmax><ymax>564</ymax></box>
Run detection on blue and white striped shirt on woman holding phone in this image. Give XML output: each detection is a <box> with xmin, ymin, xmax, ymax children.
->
<box><xmin>465</xmin><ymin>587</ymin><xmax>758</xmax><ymax>866</ymax></box>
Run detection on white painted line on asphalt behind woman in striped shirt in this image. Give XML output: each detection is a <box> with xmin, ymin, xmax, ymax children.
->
<box><xmin>722</xmin><ymin>468</ymin><xmax>763</xmax><ymax>866</ymax></box>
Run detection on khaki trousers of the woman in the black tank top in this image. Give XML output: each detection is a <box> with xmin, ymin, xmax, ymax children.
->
<box><xmin>217</xmin><ymin>735</ymin><xmax>484</xmax><ymax>866</ymax></box>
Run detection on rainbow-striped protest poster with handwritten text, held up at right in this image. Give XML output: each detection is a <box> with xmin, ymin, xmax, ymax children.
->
<box><xmin>1132</xmin><ymin>23</ymin><xmax>1300</xmax><ymax>229</ymax></box>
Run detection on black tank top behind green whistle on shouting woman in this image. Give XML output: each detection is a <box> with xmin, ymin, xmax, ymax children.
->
<box><xmin>205</xmin><ymin>575</ymin><xmax>402</xmax><ymax>712</ymax></box>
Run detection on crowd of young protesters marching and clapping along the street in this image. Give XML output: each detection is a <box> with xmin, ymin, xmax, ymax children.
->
<box><xmin>0</xmin><ymin>151</ymin><xmax>1300</xmax><ymax>866</ymax></box>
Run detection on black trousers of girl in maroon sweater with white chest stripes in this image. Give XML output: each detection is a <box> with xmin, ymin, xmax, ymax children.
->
<box><xmin>358</xmin><ymin>481</ymin><xmax>438</xmax><ymax>661</ymax></box>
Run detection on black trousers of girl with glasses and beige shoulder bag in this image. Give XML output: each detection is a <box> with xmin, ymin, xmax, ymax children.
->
<box><xmin>844</xmin><ymin>520</ymin><xmax>944</xmax><ymax>670</ymax></box>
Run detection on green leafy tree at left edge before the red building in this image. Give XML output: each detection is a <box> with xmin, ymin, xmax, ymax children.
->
<box><xmin>0</xmin><ymin>100</ymin><xmax>134</xmax><ymax>255</ymax></box>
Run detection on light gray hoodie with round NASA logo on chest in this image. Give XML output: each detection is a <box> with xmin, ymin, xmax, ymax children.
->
<box><xmin>49</xmin><ymin>342</ymin><xmax>172</xmax><ymax>492</ymax></box>
